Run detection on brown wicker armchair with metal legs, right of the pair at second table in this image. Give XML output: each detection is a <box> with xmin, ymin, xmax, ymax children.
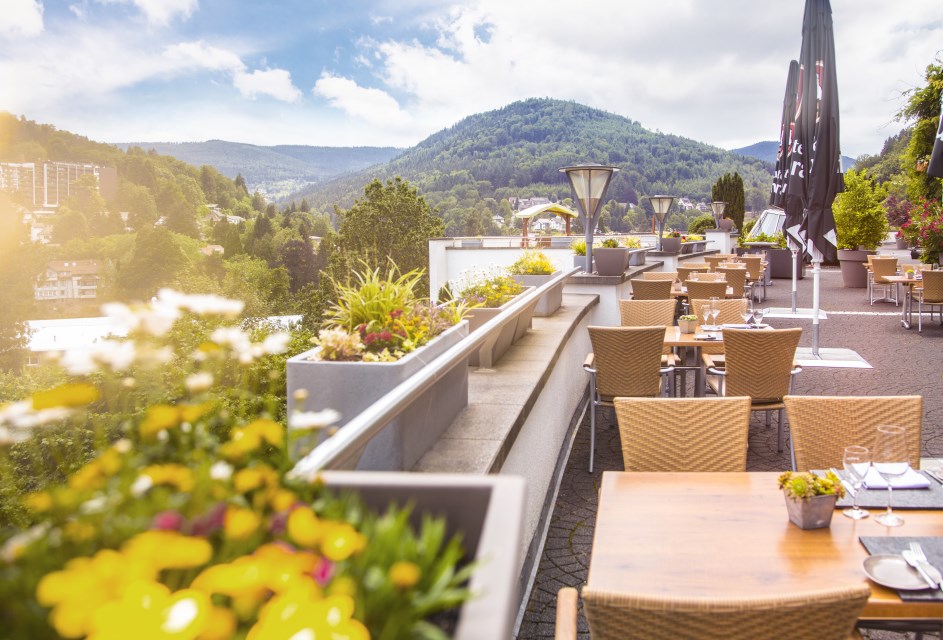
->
<box><xmin>705</xmin><ymin>328</ymin><xmax>802</xmax><ymax>451</ymax></box>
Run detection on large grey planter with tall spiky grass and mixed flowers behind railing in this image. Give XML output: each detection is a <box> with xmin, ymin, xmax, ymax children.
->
<box><xmin>288</xmin><ymin>267</ymin><xmax>469</xmax><ymax>471</ymax></box>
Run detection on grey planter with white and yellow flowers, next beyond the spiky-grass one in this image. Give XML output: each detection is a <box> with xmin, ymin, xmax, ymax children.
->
<box><xmin>450</xmin><ymin>268</ymin><xmax>538</xmax><ymax>368</ymax></box>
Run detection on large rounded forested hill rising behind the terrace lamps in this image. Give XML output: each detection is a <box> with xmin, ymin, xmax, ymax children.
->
<box><xmin>294</xmin><ymin>99</ymin><xmax>772</xmax><ymax>230</ymax></box>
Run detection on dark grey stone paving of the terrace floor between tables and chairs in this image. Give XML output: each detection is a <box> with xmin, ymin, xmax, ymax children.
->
<box><xmin>518</xmin><ymin>247</ymin><xmax>943</xmax><ymax>640</ymax></box>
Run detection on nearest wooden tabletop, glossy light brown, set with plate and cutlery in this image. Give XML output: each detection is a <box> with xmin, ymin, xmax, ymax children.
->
<box><xmin>587</xmin><ymin>471</ymin><xmax>943</xmax><ymax>620</ymax></box>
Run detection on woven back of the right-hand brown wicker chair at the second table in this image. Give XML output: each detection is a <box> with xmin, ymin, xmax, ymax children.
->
<box><xmin>724</xmin><ymin>328</ymin><xmax>802</xmax><ymax>403</ymax></box>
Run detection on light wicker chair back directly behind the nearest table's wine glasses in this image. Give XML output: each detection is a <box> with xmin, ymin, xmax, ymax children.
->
<box><xmin>783</xmin><ymin>396</ymin><xmax>923</xmax><ymax>471</ymax></box>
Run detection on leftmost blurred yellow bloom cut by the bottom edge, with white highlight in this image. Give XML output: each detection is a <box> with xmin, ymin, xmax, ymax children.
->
<box><xmin>89</xmin><ymin>581</ymin><xmax>211</xmax><ymax>640</ymax></box>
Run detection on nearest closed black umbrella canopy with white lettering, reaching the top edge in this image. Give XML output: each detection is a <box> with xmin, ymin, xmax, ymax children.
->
<box><xmin>786</xmin><ymin>0</ymin><xmax>844</xmax><ymax>262</ymax></box>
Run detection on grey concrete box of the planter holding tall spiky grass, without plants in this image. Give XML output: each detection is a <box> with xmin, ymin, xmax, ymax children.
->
<box><xmin>287</xmin><ymin>322</ymin><xmax>469</xmax><ymax>471</ymax></box>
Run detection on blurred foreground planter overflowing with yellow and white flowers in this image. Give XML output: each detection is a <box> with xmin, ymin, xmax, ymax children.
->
<box><xmin>0</xmin><ymin>295</ymin><xmax>523</xmax><ymax>640</ymax></box>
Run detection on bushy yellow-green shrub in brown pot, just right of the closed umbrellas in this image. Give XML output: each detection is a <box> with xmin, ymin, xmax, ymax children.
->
<box><xmin>832</xmin><ymin>170</ymin><xmax>888</xmax><ymax>288</ymax></box>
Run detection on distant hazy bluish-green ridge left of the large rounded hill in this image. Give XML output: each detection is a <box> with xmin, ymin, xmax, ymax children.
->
<box><xmin>117</xmin><ymin>140</ymin><xmax>402</xmax><ymax>200</ymax></box>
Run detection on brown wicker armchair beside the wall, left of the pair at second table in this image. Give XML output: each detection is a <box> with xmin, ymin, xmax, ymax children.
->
<box><xmin>583</xmin><ymin>326</ymin><xmax>674</xmax><ymax>473</ymax></box>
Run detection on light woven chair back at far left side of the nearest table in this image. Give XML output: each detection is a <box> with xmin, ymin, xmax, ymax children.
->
<box><xmin>615</xmin><ymin>398</ymin><xmax>750</xmax><ymax>471</ymax></box>
